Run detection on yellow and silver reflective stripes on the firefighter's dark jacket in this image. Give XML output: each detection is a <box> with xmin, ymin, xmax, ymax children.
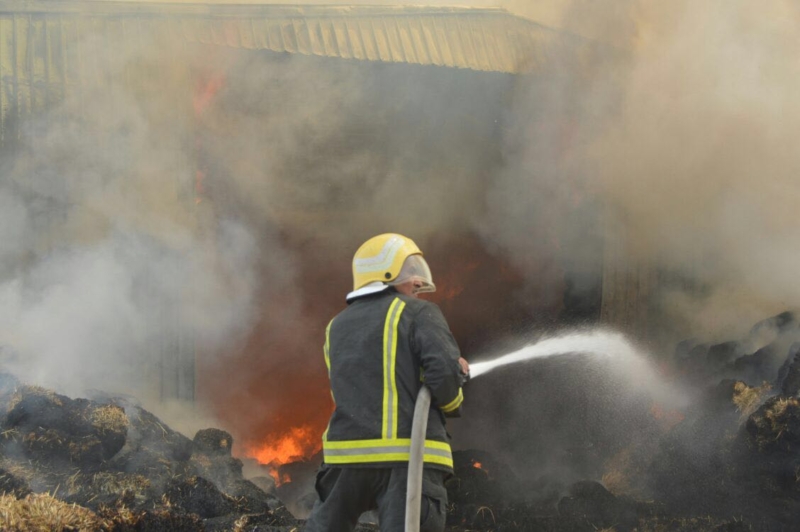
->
<box><xmin>322</xmin><ymin>298</ymin><xmax>454</xmax><ymax>468</ymax></box>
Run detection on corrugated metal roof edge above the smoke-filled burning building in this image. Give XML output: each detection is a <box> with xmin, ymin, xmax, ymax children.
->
<box><xmin>0</xmin><ymin>0</ymin><xmax>559</xmax><ymax>73</ymax></box>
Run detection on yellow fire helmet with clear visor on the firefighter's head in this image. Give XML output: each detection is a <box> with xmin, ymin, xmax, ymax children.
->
<box><xmin>353</xmin><ymin>233</ymin><xmax>436</xmax><ymax>293</ymax></box>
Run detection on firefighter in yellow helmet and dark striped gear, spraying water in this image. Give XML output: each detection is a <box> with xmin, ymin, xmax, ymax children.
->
<box><xmin>305</xmin><ymin>233</ymin><xmax>469</xmax><ymax>532</ymax></box>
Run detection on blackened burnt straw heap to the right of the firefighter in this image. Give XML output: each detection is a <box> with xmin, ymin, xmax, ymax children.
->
<box><xmin>438</xmin><ymin>312</ymin><xmax>800</xmax><ymax>532</ymax></box>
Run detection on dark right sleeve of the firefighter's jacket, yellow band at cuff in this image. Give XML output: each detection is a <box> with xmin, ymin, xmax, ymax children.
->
<box><xmin>413</xmin><ymin>302</ymin><xmax>464</xmax><ymax>417</ymax></box>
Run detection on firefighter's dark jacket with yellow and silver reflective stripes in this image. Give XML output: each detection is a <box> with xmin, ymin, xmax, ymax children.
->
<box><xmin>322</xmin><ymin>288</ymin><xmax>463</xmax><ymax>471</ymax></box>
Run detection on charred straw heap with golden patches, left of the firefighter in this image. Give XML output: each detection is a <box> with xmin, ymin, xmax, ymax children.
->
<box><xmin>0</xmin><ymin>374</ymin><xmax>296</xmax><ymax>531</ymax></box>
